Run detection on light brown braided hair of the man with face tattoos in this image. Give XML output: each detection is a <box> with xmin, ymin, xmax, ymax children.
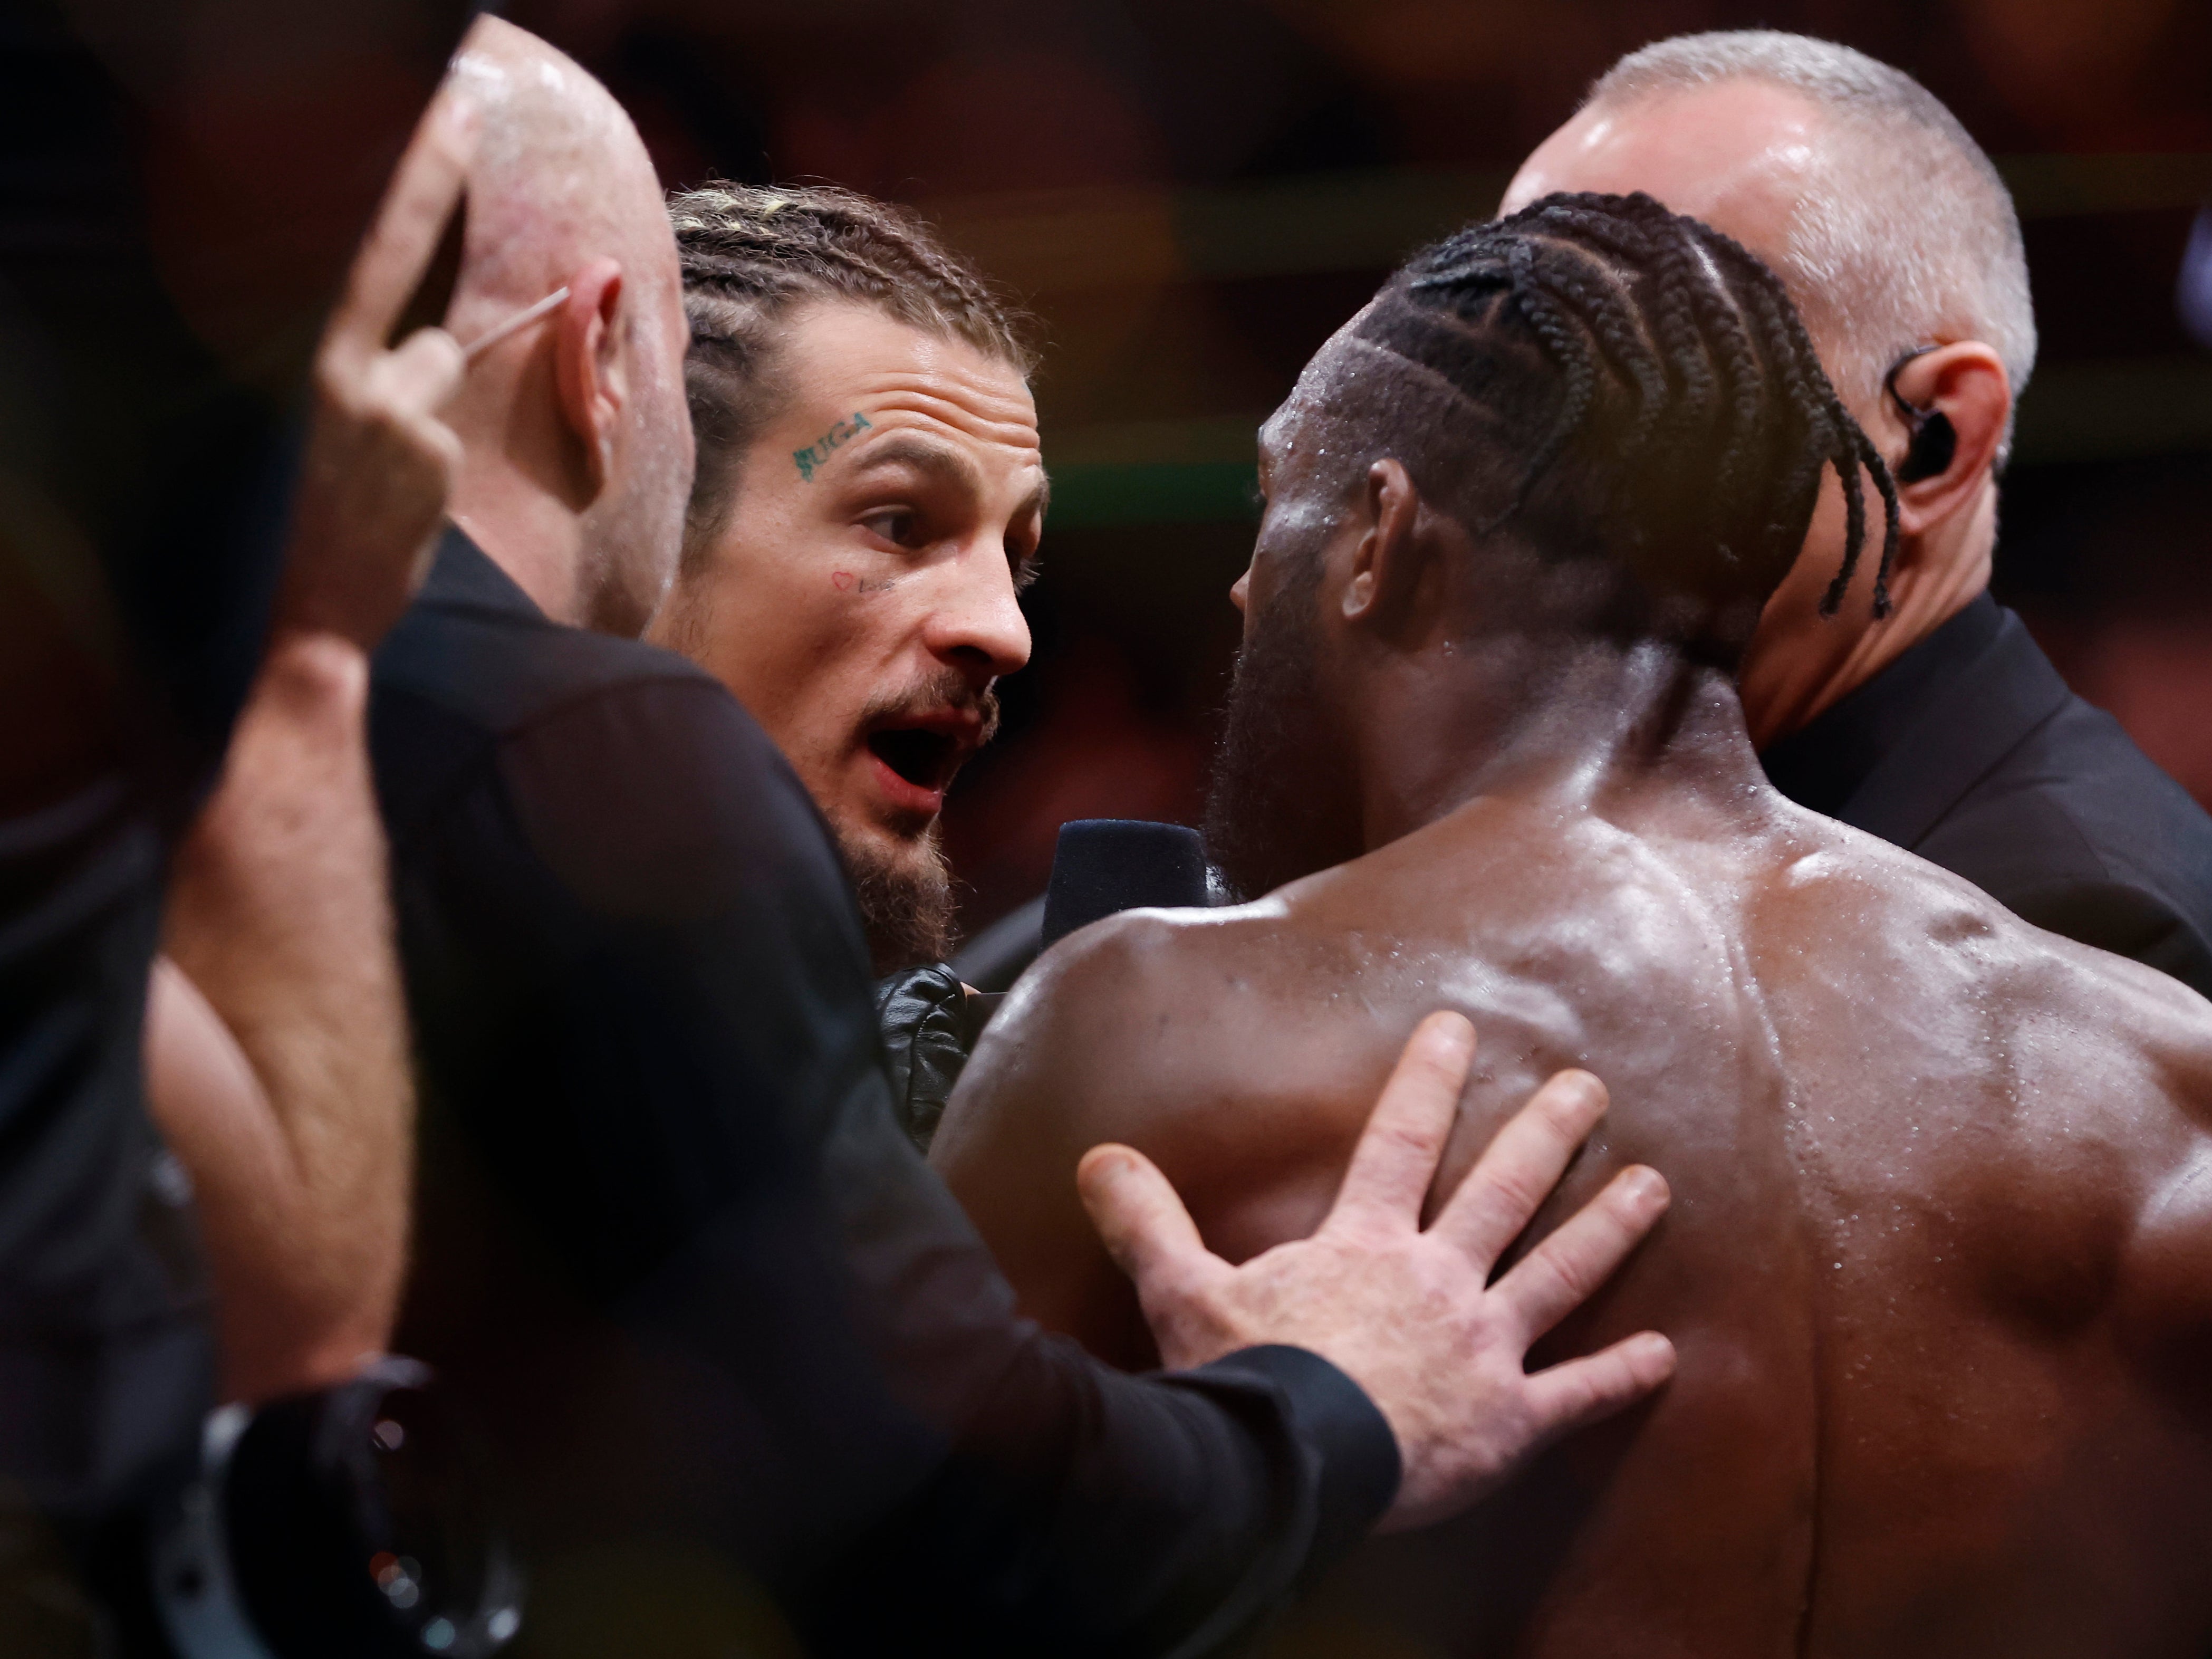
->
<box><xmin>668</xmin><ymin>181</ymin><xmax>1035</xmax><ymax>560</ymax></box>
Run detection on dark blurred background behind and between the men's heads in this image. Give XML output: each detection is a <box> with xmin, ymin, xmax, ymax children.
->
<box><xmin>509</xmin><ymin>0</ymin><xmax>2212</xmax><ymax>929</ymax></box>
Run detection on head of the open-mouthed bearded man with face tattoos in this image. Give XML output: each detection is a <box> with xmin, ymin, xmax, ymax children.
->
<box><xmin>652</xmin><ymin>184</ymin><xmax>1049</xmax><ymax>973</ymax></box>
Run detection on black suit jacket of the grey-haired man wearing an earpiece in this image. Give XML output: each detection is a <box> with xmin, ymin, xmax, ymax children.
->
<box><xmin>1761</xmin><ymin>593</ymin><xmax>2212</xmax><ymax>995</ymax></box>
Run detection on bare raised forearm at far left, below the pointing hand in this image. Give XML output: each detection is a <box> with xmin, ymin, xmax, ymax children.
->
<box><xmin>150</xmin><ymin>632</ymin><xmax>413</xmax><ymax>1398</ymax></box>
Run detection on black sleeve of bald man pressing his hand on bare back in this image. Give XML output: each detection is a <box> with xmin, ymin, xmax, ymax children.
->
<box><xmin>398</xmin><ymin>679</ymin><xmax>1398</xmax><ymax>1655</ymax></box>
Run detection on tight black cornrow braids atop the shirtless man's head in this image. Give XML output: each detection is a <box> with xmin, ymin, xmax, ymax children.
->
<box><xmin>1358</xmin><ymin>193</ymin><xmax>1898</xmax><ymax>617</ymax></box>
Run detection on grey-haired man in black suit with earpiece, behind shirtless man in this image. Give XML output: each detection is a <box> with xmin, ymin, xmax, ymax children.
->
<box><xmin>1504</xmin><ymin>31</ymin><xmax>2212</xmax><ymax>995</ymax></box>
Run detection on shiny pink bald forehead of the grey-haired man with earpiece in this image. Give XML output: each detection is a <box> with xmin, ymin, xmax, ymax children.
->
<box><xmin>1497</xmin><ymin>80</ymin><xmax>1834</xmax><ymax>261</ymax></box>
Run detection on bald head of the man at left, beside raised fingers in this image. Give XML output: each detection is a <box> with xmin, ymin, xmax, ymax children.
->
<box><xmin>443</xmin><ymin>18</ymin><xmax>693</xmax><ymax>635</ymax></box>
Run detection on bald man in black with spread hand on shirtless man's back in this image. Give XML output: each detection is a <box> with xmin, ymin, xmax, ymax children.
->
<box><xmin>372</xmin><ymin>20</ymin><xmax>1672</xmax><ymax>1655</ymax></box>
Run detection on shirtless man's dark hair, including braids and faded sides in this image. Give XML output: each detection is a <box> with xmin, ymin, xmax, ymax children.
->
<box><xmin>1349</xmin><ymin>195</ymin><xmax>1898</xmax><ymax>657</ymax></box>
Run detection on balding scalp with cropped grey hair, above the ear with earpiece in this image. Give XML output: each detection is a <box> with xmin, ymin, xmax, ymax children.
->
<box><xmin>1502</xmin><ymin>31</ymin><xmax>2035</xmax><ymax>449</ymax></box>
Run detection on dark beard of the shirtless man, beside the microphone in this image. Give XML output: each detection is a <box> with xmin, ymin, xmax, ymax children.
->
<box><xmin>1206</xmin><ymin>558</ymin><xmax>1358</xmax><ymax>898</ymax></box>
